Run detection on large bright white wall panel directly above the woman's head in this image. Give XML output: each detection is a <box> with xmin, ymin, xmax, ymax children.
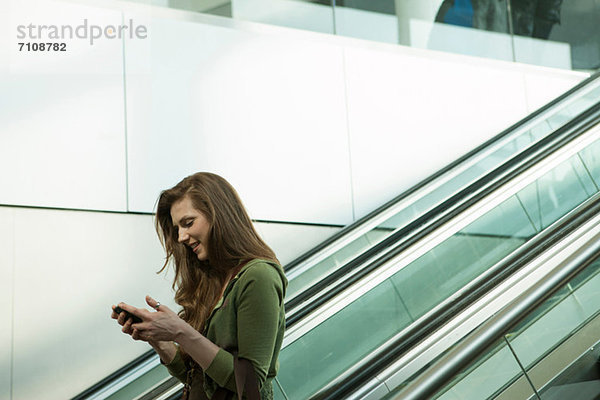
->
<box><xmin>126</xmin><ymin>16</ymin><xmax>352</xmax><ymax>224</ymax></box>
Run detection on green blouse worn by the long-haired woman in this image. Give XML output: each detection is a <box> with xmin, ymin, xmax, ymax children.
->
<box><xmin>166</xmin><ymin>259</ymin><xmax>287</xmax><ymax>400</ymax></box>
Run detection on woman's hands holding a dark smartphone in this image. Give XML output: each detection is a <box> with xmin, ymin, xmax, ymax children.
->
<box><xmin>112</xmin><ymin>296</ymin><xmax>186</xmax><ymax>347</ymax></box>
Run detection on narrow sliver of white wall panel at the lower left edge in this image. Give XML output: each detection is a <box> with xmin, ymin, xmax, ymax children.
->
<box><xmin>0</xmin><ymin>207</ymin><xmax>14</xmax><ymax>399</ymax></box>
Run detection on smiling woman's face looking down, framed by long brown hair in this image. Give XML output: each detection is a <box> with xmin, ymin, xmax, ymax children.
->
<box><xmin>171</xmin><ymin>197</ymin><xmax>210</xmax><ymax>261</ymax></box>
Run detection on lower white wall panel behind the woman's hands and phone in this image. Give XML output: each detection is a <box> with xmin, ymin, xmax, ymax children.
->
<box><xmin>13</xmin><ymin>209</ymin><xmax>173</xmax><ymax>400</ymax></box>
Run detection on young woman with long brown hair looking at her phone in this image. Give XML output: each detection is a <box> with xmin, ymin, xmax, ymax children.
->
<box><xmin>112</xmin><ymin>172</ymin><xmax>287</xmax><ymax>400</ymax></box>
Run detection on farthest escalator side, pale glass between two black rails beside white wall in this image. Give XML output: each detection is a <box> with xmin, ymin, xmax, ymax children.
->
<box><xmin>286</xmin><ymin>70</ymin><xmax>600</xmax><ymax>326</ymax></box>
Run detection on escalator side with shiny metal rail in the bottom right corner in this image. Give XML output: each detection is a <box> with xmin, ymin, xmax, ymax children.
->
<box><xmin>394</xmin><ymin>196</ymin><xmax>600</xmax><ymax>400</ymax></box>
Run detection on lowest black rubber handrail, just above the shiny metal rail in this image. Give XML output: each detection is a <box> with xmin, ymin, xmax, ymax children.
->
<box><xmin>312</xmin><ymin>107</ymin><xmax>600</xmax><ymax>400</ymax></box>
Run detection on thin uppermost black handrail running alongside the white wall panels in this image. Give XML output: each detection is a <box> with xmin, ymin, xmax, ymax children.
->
<box><xmin>285</xmin><ymin>71</ymin><xmax>600</xmax><ymax>272</ymax></box>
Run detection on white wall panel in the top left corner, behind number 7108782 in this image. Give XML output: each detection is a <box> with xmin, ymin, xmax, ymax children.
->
<box><xmin>0</xmin><ymin>1</ymin><xmax>126</xmax><ymax>210</ymax></box>
